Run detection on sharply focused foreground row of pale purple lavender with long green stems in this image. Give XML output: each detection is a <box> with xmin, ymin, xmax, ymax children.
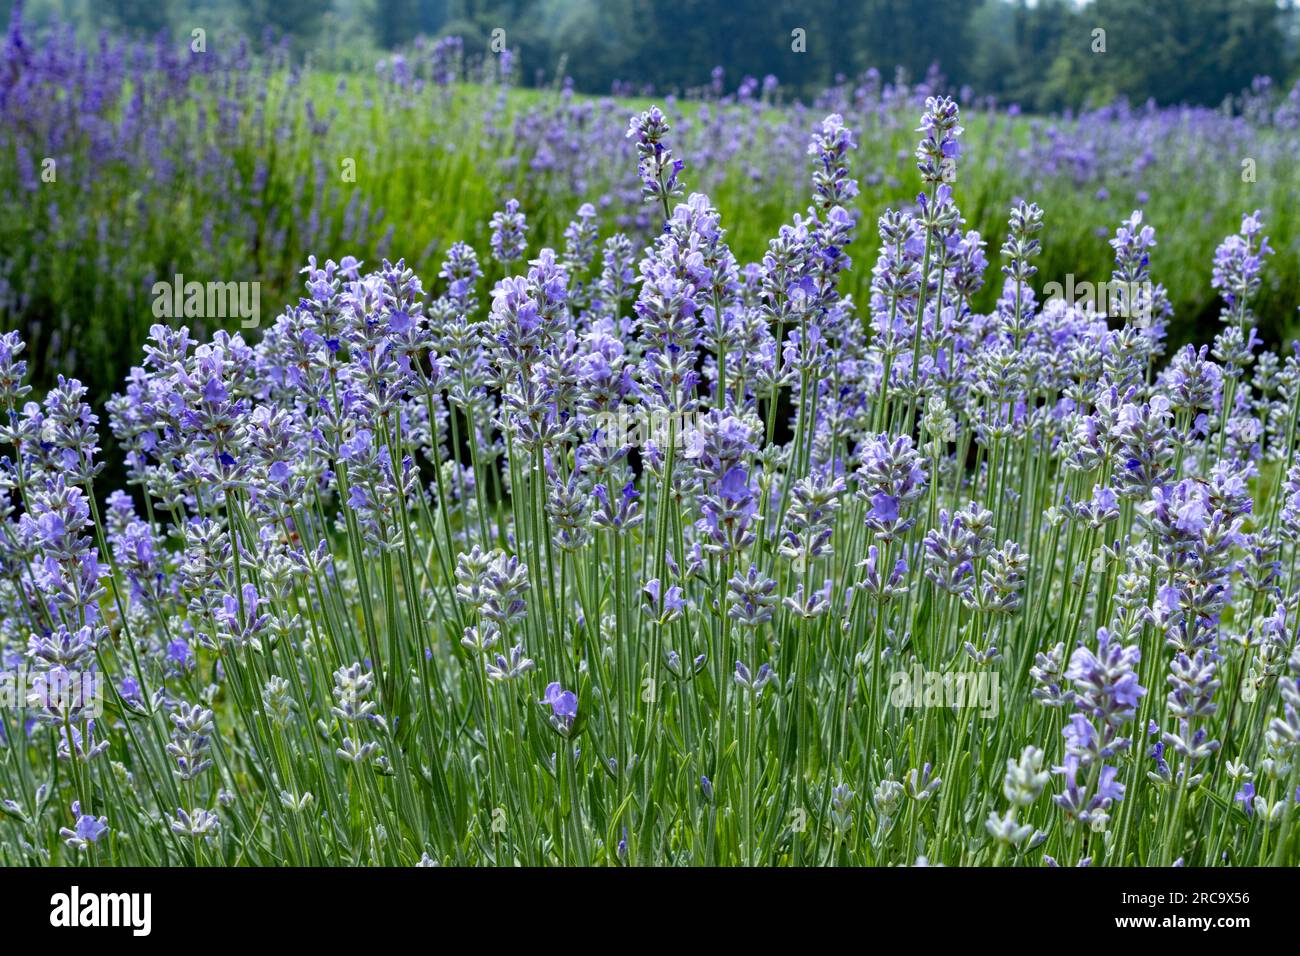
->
<box><xmin>0</xmin><ymin>85</ymin><xmax>1300</xmax><ymax>865</ymax></box>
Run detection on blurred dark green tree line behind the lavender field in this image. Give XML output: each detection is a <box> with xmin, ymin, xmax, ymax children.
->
<box><xmin>10</xmin><ymin>0</ymin><xmax>1300</xmax><ymax>112</ymax></box>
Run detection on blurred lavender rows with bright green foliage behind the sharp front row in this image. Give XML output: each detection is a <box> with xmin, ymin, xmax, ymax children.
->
<box><xmin>0</xmin><ymin>7</ymin><xmax>1300</xmax><ymax>398</ymax></box>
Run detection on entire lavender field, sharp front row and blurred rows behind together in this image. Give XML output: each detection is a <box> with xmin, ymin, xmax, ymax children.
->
<box><xmin>0</xmin><ymin>5</ymin><xmax>1300</xmax><ymax>866</ymax></box>
